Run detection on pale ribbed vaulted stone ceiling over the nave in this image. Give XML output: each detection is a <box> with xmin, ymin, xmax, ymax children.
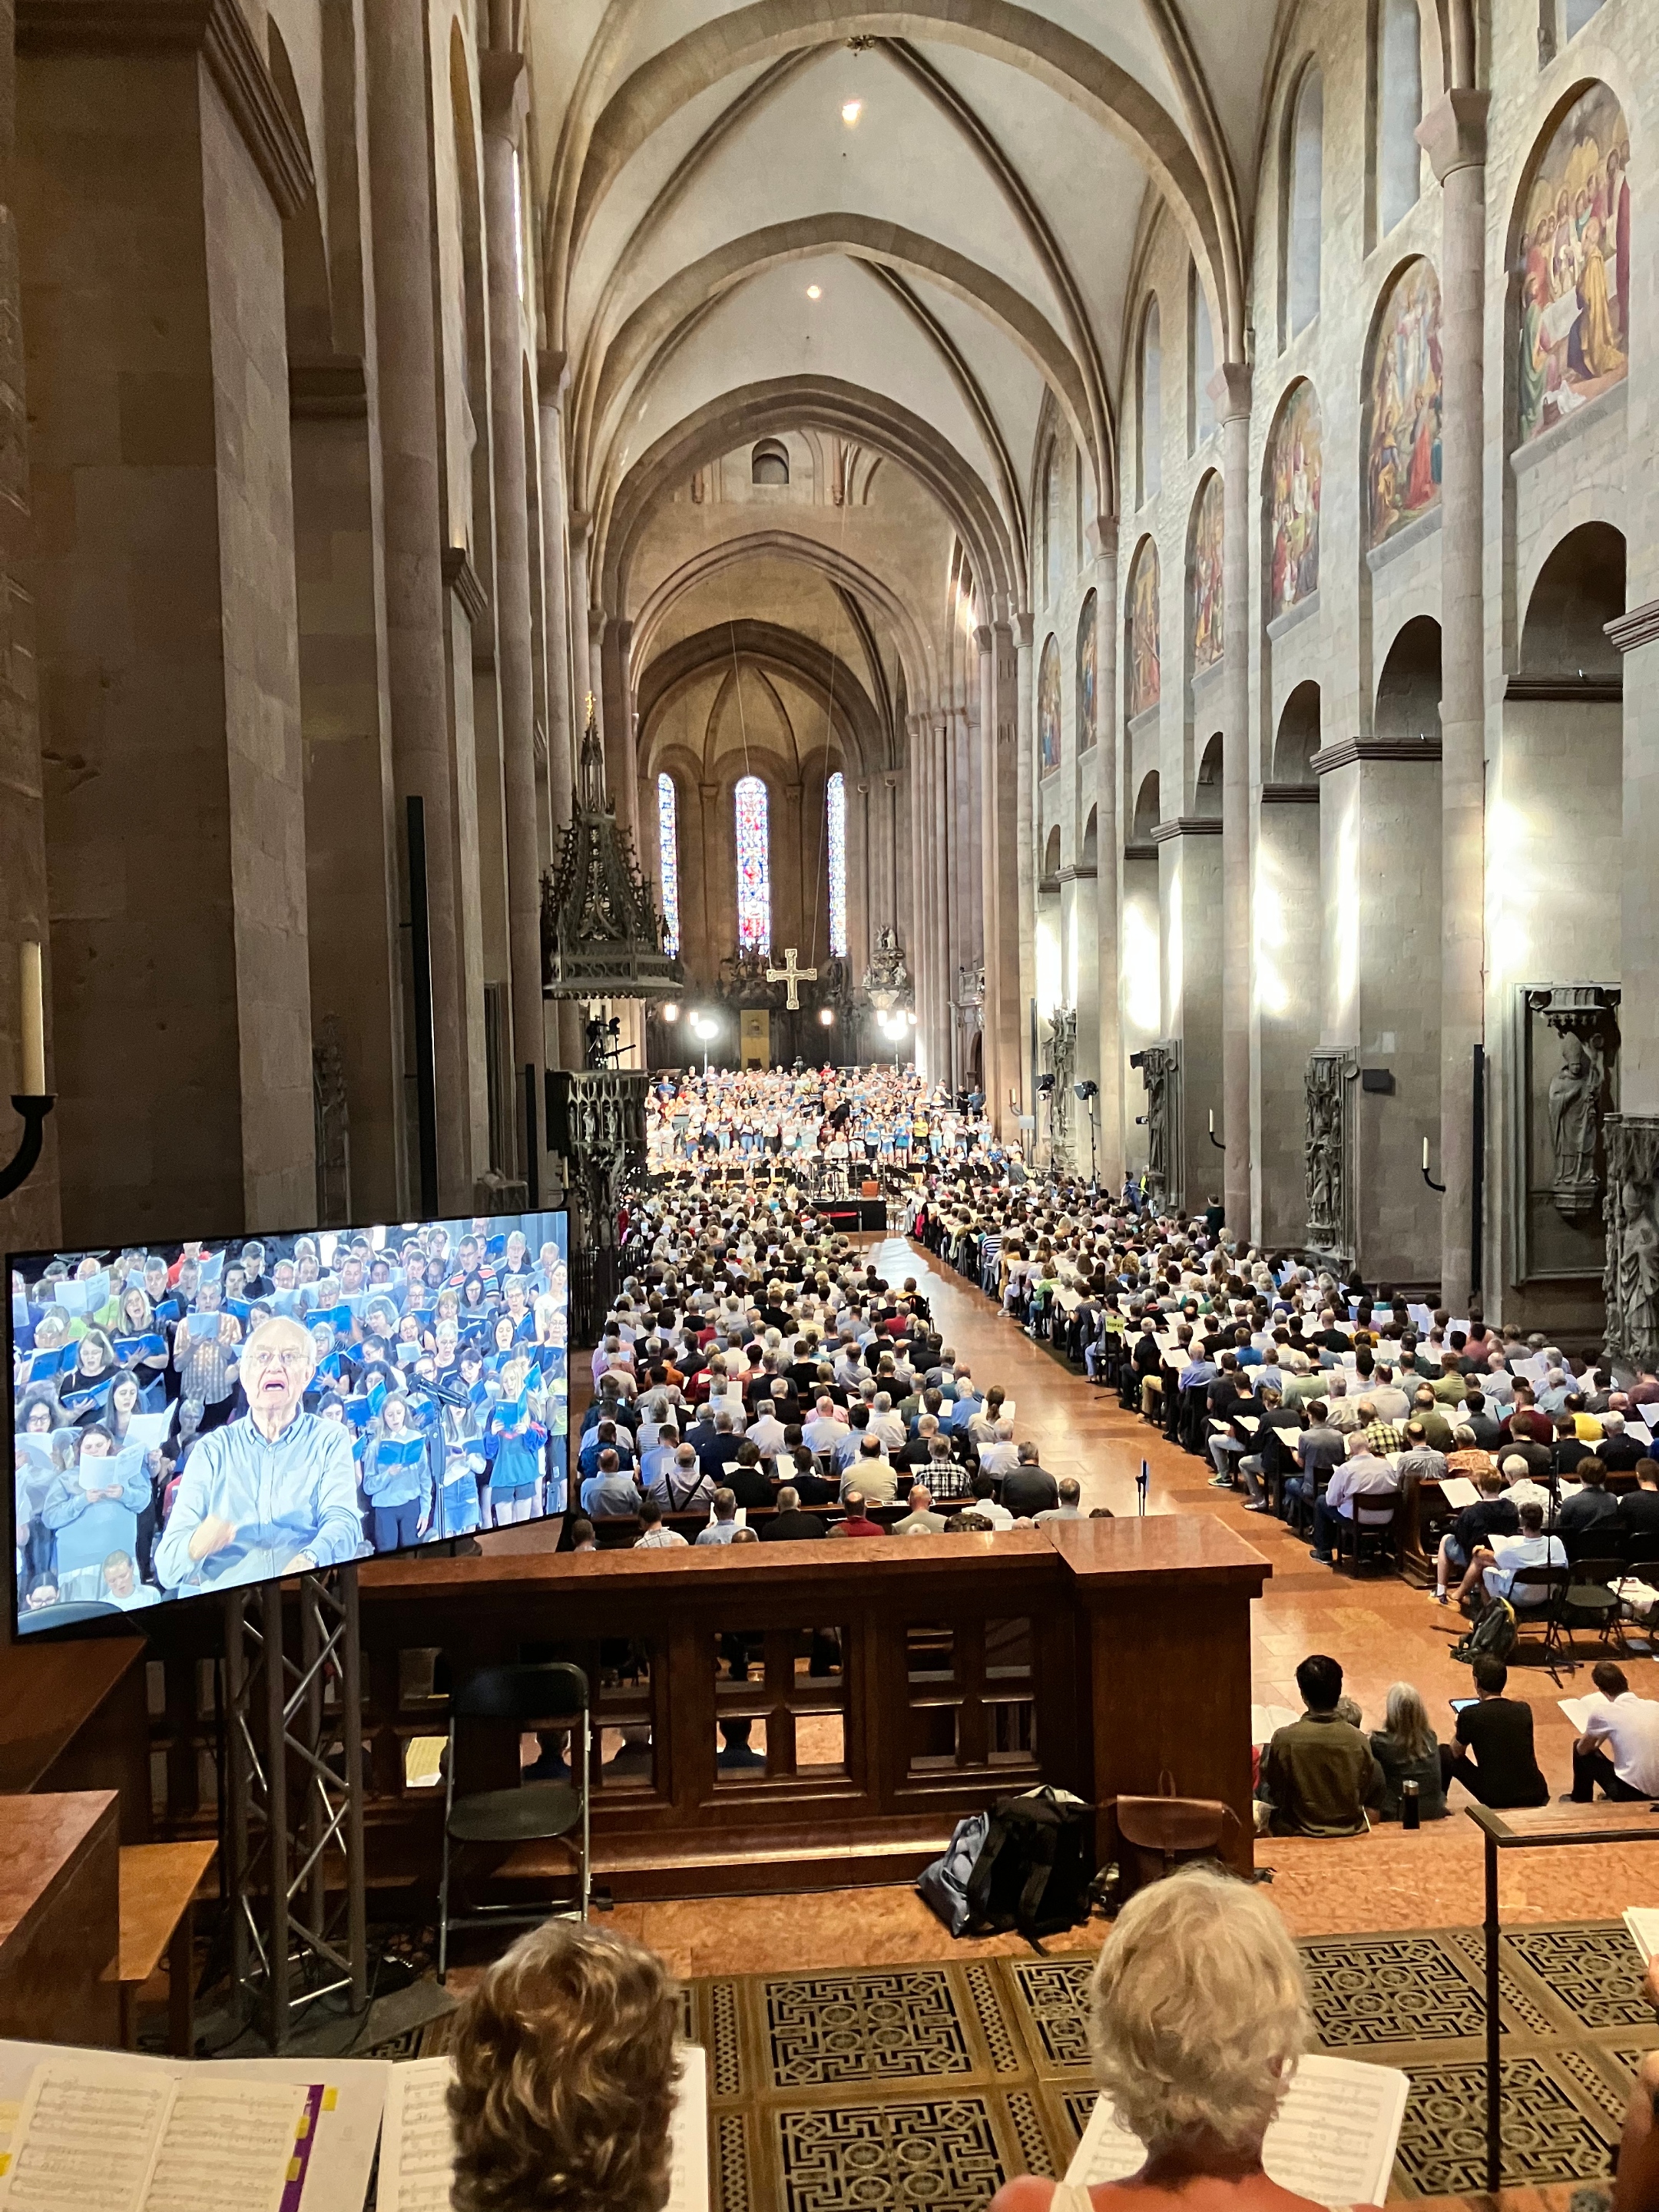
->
<box><xmin>528</xmin><ymin>0</ymin><xmax>1277</xmax><ymax>615</ymax></box>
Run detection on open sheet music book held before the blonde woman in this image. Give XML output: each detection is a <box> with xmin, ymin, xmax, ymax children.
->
<box><xmin>1066</xmin><ymin>2053</ymin><xmax>1411</xmax><ymax>2212</ymax></box>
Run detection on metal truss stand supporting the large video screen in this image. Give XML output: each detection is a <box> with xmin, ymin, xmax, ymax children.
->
<box><xmin>226</xmin><ymin>1564</ymin><xmax>369</xmax><ymax>2053</ymax></box>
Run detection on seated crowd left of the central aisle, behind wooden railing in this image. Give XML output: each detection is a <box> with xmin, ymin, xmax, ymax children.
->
<box><xmin>575</xmin><ymin>1177</ymin><xmax>1084</xmax><ymax>1548</ymax></box>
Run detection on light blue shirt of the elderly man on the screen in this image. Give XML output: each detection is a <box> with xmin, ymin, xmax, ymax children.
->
<box><xmin>155</xmin><ymin>1413</ymin><xmax>363</xmax><ymax>1591</ymax></box>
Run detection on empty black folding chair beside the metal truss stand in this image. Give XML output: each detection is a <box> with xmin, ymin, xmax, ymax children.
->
<box><xmin>438</xmin><ymin>1659</ymin><xmax>593</xmax><ymax>1982</ymax></box>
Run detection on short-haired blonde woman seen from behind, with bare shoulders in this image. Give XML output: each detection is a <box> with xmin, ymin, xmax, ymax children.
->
<box><xmin>993</xmin><ymin>1867</ymin><xmax>1314</xmax><ymax>2212</ymax></box>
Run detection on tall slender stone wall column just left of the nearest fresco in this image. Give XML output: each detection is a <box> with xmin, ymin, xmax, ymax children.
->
<box><xmin>1418</xmin><ymin>88</ymin><xmax>1488</xmax><ymax>1314</ymax></box>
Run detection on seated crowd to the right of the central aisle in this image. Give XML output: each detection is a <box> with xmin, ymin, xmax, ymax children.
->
<box><xmin>913</xmin><ymin>1174</ymin><xmax>1659</xmax><ymax>1611</ymax></box>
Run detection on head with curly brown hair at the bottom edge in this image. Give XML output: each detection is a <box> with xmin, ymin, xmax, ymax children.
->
<box><xmin>449</xmin><ymin>1920</ymin><xmax>679</xmax><ymax>2212</ymax></box>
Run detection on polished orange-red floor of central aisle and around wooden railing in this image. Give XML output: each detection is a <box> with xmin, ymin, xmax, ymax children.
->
<box><xmin>615</xmin><ymin>1239</ymin><xmax>1659</xmax><ymax>1975</ymax></box>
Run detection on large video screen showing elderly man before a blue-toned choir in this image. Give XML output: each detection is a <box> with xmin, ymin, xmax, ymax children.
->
<box><xmin>9</xmin><ymin>1212</ymin><xmax>568</xmax><ymax>1632</ymax></box>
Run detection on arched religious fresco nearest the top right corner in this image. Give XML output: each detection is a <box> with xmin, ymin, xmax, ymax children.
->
<box><xmin>1515</xmin><ymin>84</ymin><xmax>1631</xmax><ymax>445</ymax></box>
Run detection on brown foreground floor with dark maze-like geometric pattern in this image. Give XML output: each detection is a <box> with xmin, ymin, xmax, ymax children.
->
<box><xmin>686</xmin><ymin>1920</ymin><xmax>1659</xmax><ymax>2212</ymax></box>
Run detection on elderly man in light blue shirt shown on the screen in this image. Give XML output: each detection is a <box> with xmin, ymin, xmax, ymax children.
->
<box><xmin>155</xmin><ymin>1318</ymin><xmax>363</xmax><ymax>1591</ymax></box>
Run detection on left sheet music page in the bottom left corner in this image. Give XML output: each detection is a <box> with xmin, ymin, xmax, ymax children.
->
<box><xmin>0</xmin><ymin>2053</ymin><xmax>173</xmax><ymax>2212</ymax></box>
